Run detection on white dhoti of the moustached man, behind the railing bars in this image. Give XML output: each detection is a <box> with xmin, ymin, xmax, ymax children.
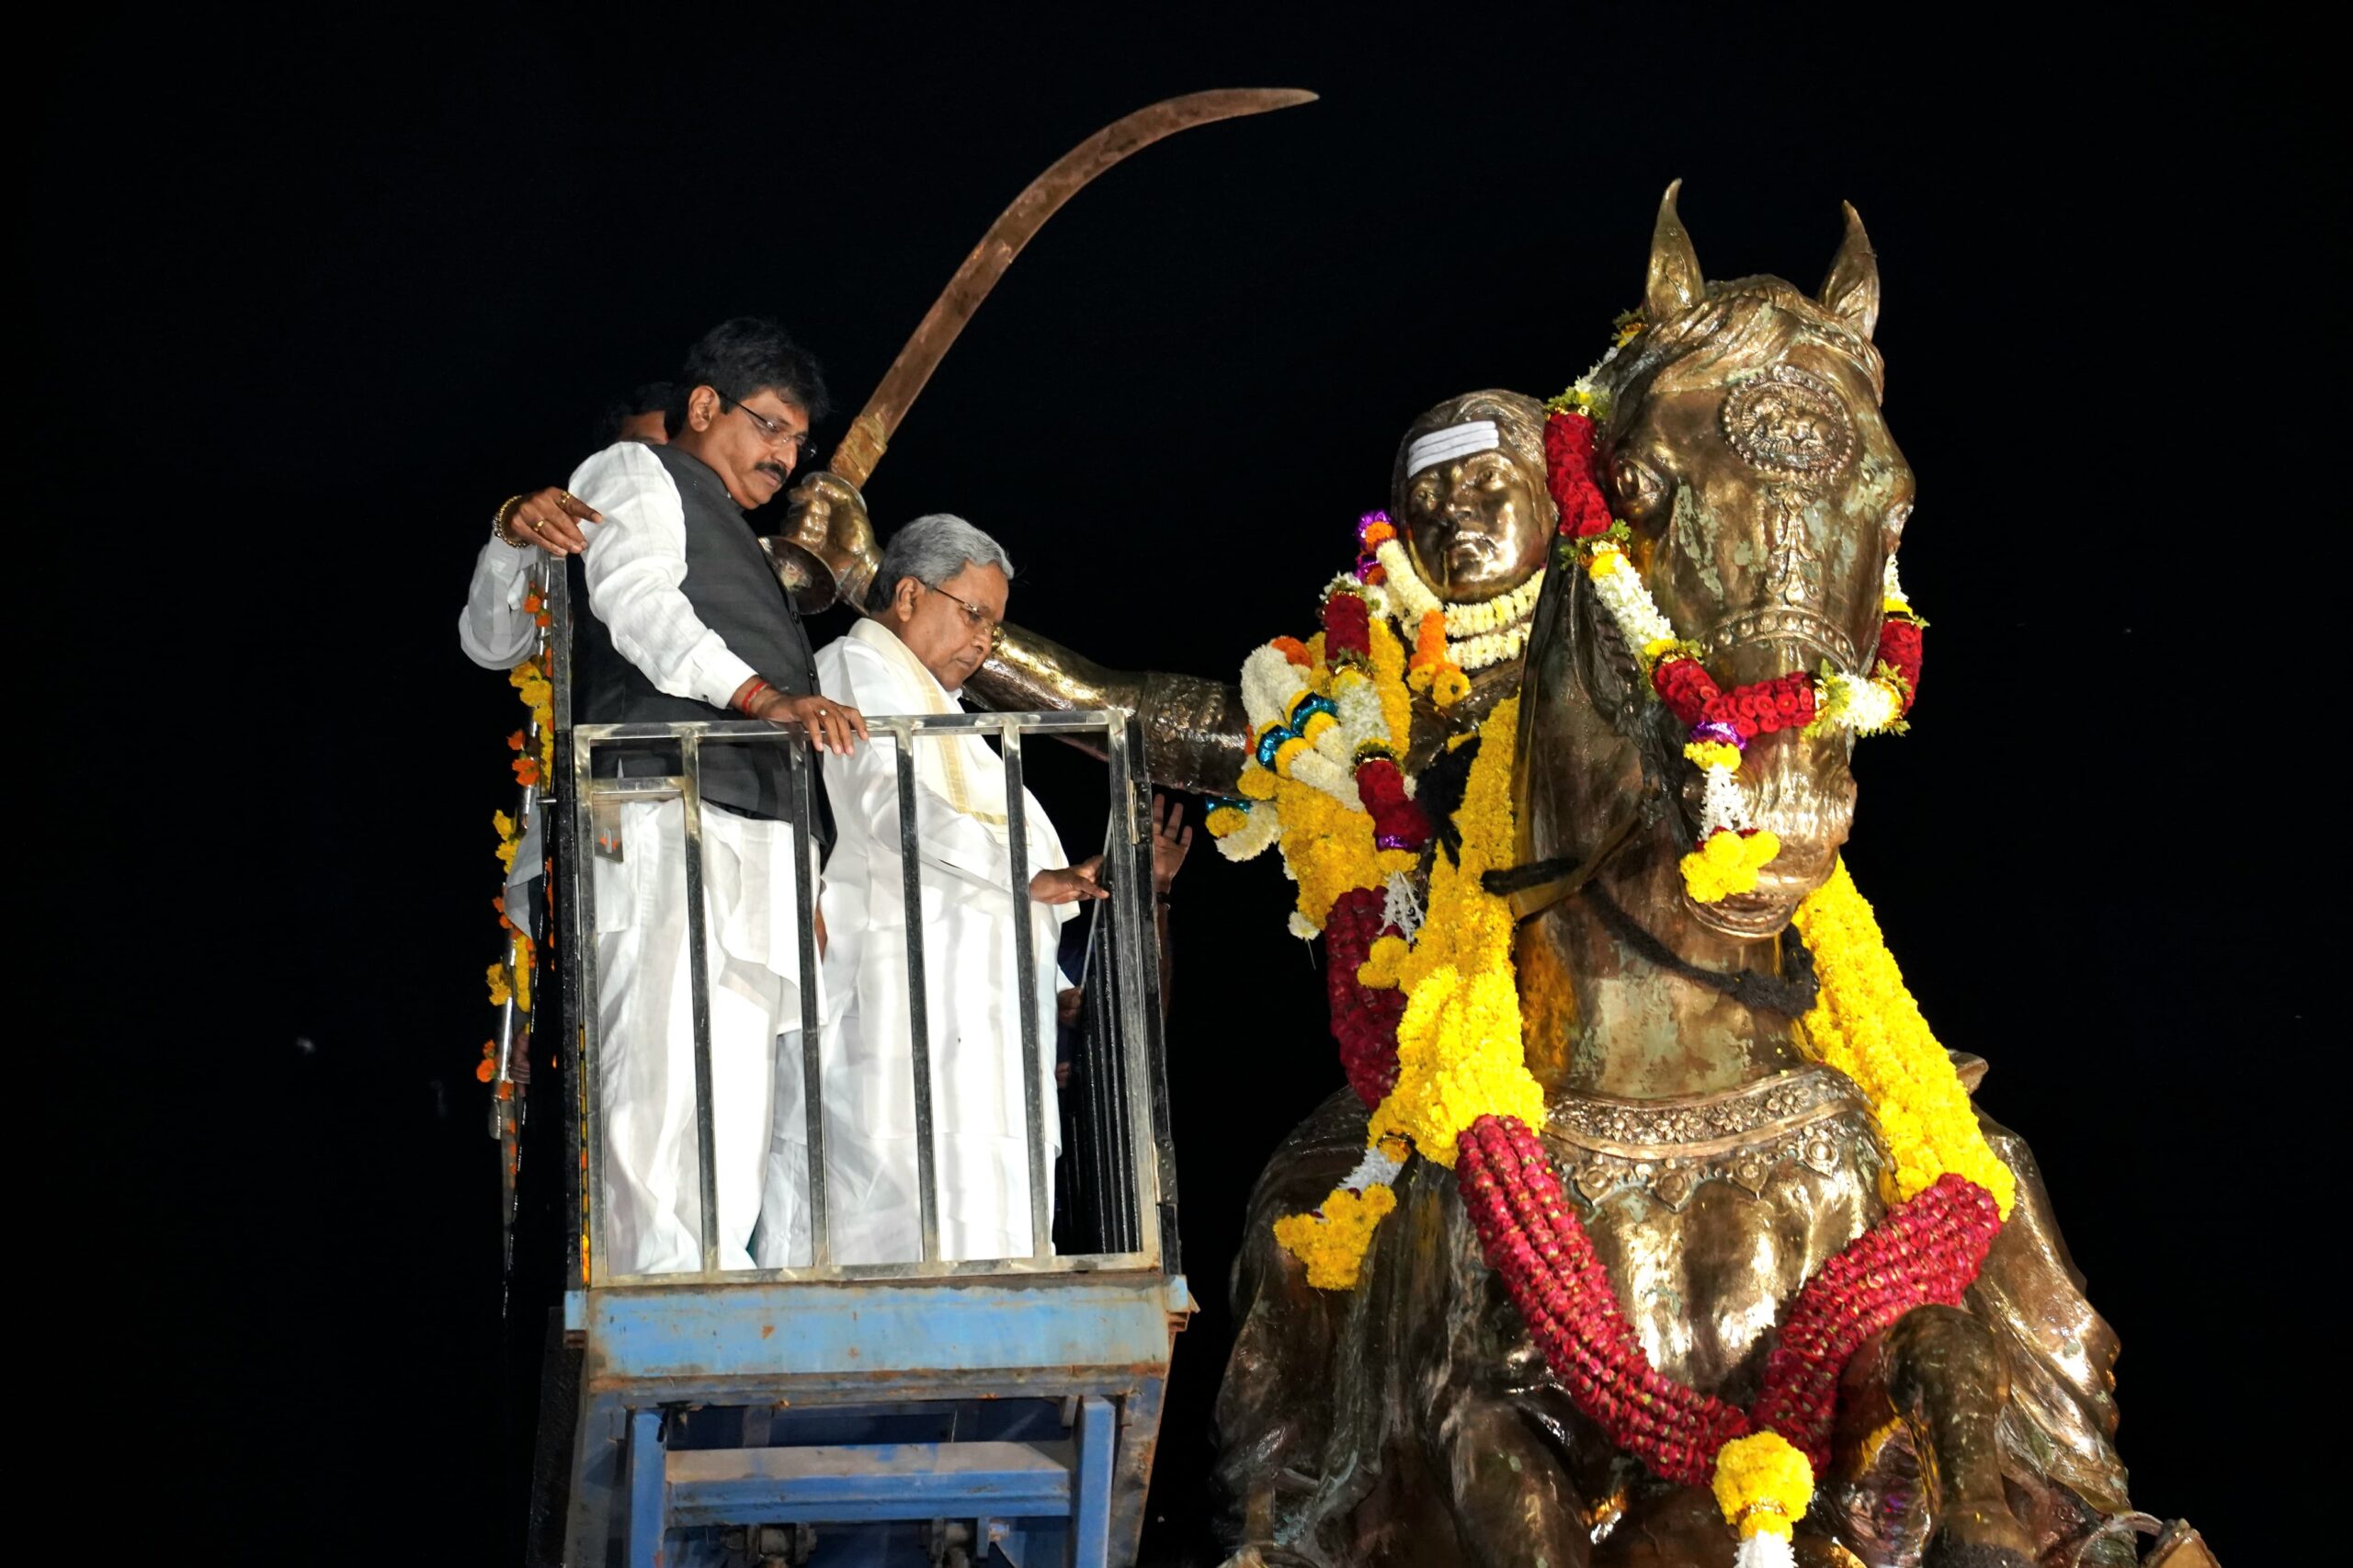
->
<box><xmin>593</xmin><ymin>801</ymin><xmax>800</xmax><ymax>1274</ymax></box>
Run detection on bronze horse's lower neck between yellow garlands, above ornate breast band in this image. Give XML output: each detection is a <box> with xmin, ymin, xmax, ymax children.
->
<box><xmin>1518</xmin><ymin>834</ymin><xmax>1805</xmax><ymax>1099</ymax></box>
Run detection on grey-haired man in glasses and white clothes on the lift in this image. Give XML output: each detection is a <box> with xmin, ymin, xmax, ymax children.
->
<box><xmin>756</xmin><ymin>516</ymin><xmax>1106</xmax><ymax>1267</ymax></box>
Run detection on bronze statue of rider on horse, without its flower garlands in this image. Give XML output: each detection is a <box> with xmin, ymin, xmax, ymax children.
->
<box><xmin>780</xmin><ymin>188</ymin><xmax>2211</xmax><ymax>1568</ymax></box>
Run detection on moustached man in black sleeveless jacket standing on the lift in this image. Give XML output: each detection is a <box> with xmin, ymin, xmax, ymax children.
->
<box><xmin>570</xmin><ymin>318</ymin><xmax>866</xmax><ymax>1274</ymax></box>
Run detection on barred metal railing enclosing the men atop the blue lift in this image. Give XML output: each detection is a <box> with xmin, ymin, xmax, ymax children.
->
<box><xmin>558</xmin><ymin>706</ymin><xmax>1174</xmax><ymax>1286</ymax></box>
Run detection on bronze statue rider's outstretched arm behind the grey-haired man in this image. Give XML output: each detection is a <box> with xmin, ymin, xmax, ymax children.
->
<box><xmin>965</xmin><ymin>626</ymin><xmax>1249</xmax><ymax>796</ymax></box>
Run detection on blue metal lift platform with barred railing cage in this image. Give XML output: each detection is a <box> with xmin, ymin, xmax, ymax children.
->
<box><xmin>492</xmin><ymin>555</ymin><xmax>1190</xmax><ymax>1568</ymax></box>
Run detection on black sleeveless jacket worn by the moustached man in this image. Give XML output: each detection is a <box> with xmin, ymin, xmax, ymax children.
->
<box><xmin>567</xmin><ymin>448</ymin><xmax>831</xmax><ymax>843</ymax></box>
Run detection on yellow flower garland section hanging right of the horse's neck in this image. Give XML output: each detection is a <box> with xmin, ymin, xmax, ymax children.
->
<box><xmin>1793</xmin><ymin>859</ymin><xmax>2018</xmax><ymax>1220</ymax></box>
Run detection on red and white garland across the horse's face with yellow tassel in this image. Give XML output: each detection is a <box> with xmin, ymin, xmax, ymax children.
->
<box><xmin>1543</xmin><ymin>403</ymin><xmax>1927</xmax><ymax>904</ymax></box>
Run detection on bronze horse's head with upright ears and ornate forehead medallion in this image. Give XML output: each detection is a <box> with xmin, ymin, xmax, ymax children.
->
<box><xmin>1529</xmin><ymin>186</ymin><xmax>1913</xmax><ymax>937</ymax></box>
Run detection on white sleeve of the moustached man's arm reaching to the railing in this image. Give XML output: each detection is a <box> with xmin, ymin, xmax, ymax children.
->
<box><xmin>572</xmin><ymin>440</ymin><xmax>757</xmax><ymax>709</ymax></box>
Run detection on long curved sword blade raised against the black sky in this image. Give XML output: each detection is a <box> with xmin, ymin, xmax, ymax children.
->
<box><xmin>828</xmin><ymin>87</ymin><xmax>1315</xmax><ymax>485</ymax></box>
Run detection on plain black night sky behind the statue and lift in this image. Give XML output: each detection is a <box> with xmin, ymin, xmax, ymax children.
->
<box><xmin>28</xmin><ymin>5</ymin><xmax>2344</xmax><ymax>1565</ymax></box>
